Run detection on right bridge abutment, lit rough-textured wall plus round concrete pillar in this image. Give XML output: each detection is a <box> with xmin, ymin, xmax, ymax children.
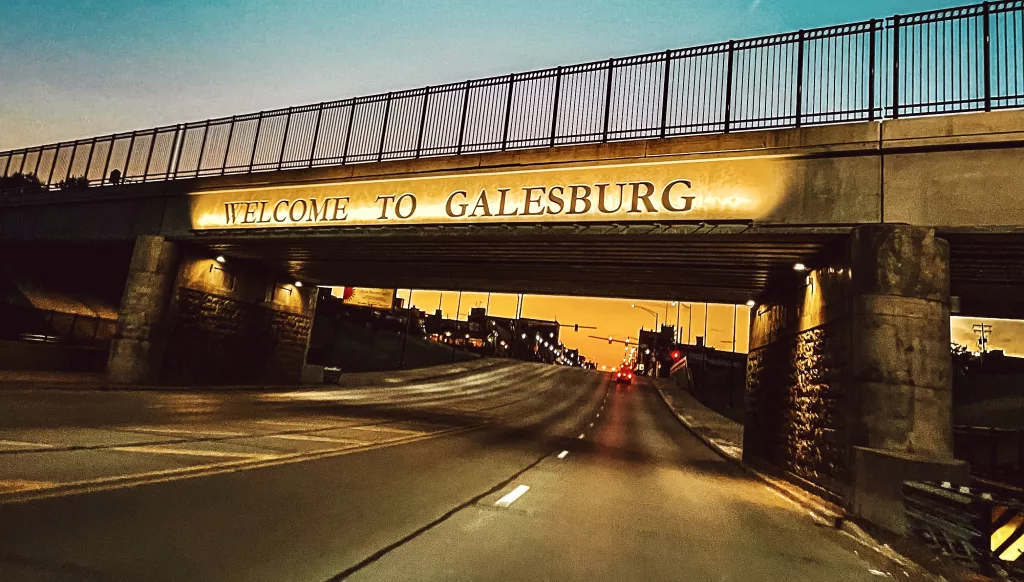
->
<box><xmin>743</xmin><ymin>224</ymin><xmax>966</xmax><ymax>531</ymax></box>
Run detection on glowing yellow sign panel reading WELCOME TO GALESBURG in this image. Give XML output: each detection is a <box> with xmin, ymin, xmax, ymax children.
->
<box><xmin>193</xmin><ymin>158</ymin><xmax>785</xmax><ymax>230</ymax></box>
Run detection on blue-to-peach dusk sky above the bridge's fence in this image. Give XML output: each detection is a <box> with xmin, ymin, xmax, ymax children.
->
<box><xmin>0</xmin><ymin>0</ymin><xmax>959</xmax><ymax>149</ymax></box>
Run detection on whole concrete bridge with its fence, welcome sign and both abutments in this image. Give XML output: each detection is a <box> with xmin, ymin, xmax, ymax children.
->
<box><xmin>0</xmin><ymin>2</ymin><xmax>1024</xmax><ymax>524</ymax></box>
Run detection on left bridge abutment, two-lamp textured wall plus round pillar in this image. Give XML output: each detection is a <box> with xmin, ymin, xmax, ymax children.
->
<box><xmin>108</xmin><ymin>237</ymin><xmax>316</xmax><ymax>385</ymax></box>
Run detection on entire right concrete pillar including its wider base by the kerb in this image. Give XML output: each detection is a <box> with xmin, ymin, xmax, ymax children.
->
<box><xmin>848</xmin><ymin>224</ymin><xmax>968</xmax><ymax>534</ymax></box>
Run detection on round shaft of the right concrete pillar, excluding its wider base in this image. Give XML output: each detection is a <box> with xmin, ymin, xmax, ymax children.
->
<box><xmin>848</xmin><ymin>224</ymin><xmax>952</xmax><ymax>459</ymax></box>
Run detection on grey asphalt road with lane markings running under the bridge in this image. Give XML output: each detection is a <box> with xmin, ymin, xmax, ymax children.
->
<box><xmin>0</xmin><ymin>364</ymin><xmax>909</xmax><ymax>582</ymax></box>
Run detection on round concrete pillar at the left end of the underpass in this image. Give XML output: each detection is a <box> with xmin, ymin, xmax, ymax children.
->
<box><xmin>106</xmin><ymin>236</ymin><xmax>177</xmax><ymax>384</ymax></box>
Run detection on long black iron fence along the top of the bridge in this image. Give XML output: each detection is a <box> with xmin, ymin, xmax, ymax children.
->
<box><xmin>0</xmin><ymin>0</ymin><xmax>1024</xmax><ymax>194</ymax></box>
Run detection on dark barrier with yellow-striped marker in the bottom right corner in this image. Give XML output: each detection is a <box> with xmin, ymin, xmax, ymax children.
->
<box><xmin>903</xmin><ymin>482</ymin><xmax>1024</xmax><ymax>580</ymax></box>
